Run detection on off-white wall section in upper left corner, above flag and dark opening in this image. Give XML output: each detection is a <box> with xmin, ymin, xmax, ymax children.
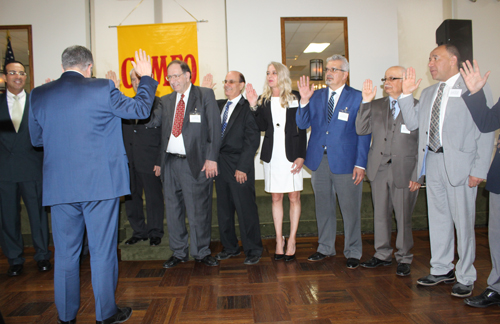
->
<box><xmin>0</xmin><ymin>0</ymin><xmax>89</xmax><ymax>86</ymax></box>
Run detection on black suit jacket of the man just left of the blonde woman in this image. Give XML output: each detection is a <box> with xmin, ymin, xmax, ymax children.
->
<box><xmin>217</xmin><ymin>97</ymin><xmax>260</xmax><ymax>182</ymax></box>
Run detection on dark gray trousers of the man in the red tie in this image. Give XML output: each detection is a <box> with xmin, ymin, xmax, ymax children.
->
<box><xmin>162</xmin><ymin>156</ymin><xmax>214</xmax><ymax>259</ymax></box>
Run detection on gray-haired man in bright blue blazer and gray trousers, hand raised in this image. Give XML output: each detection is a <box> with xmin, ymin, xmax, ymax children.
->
<box><xmin>296</xmin><ymin>55</ymin><xmax>371</xmax><ymax>269</ymax></box>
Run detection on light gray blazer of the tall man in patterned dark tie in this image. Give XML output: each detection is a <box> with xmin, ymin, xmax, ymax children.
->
<box><xmin>398</xmin><ymin>76</ymin><xmax>494</xmax><ymax>186</ymax></box>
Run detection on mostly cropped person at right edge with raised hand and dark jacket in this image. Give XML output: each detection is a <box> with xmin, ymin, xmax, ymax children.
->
<box><xmin>460</xmin><ymin>60</ymin><xmax>500</xmax><ymax>307</ymax></box>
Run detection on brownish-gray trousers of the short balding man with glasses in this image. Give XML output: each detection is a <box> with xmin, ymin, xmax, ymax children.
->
<box><xmin>370</xmin><ymin>164</ymin><xmax>418</xmax><ymax>263</ymax></box>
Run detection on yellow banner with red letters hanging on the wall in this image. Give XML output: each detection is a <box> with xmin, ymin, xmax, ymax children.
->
<box><xmin>118</xmin><ymin>22</ymin><xmax>199</xmax><ymax>97</ymax></box>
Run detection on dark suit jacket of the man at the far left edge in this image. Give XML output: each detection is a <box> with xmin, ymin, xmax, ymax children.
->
<box><xmin>0</xmin><ymin>93</ymin><xmax>43</xmax><ymax>182</ymax></box>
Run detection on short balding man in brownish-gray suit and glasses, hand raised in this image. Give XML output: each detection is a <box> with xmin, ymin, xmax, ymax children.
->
<box><xmin>356</xmin><ymin>66</ymin><xmax>423</xmax><ymax>276</ymax></box>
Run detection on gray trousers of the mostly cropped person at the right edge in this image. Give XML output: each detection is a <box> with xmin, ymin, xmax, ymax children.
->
<box><xmin>488</xmin><ymin>192</ymin><xmax>500</xmax><ymax>293</ymax></box>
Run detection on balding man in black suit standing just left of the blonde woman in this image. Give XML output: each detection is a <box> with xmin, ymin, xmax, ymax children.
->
<box><xmin>208</xmin><ymin>71</ymin><xmax>263</xmax><ymax>265</ymax></box>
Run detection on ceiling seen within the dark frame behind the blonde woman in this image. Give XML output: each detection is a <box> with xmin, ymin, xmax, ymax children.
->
<box><xmin>285</xmin><ymin>20</ymin><xmax>346</xmax><ymax>89</ymax></box>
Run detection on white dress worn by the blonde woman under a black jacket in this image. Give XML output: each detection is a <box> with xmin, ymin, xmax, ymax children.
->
<box><xmin>264</xmin><ymin>97</ymin><xmax>303</xmax><ymax>193</ymax></box>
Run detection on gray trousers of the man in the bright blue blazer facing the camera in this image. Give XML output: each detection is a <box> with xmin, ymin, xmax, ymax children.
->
<box><xmin>311</xmin><ymin>154</ymin><xmax>363</xmax><ymax>259</ymax></box>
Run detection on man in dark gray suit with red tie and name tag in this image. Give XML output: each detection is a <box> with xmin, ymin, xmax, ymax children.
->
<box><xmin>146</xmin><ymin>60</ymin><xmax>221</xmax><ymax>268</ymax></box>
